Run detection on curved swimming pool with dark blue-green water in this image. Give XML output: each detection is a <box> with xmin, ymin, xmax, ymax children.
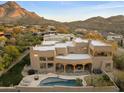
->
<box><xmin>39</xmin><ymin>77</ymin><xmax>83</xmax><ymax>86</ymax></box>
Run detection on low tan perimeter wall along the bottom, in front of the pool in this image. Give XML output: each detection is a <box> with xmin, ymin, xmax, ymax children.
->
<box><xmin>16</xmin><ymin>86</ymin><xmax>119</xmax><ymax>92</ymax></box>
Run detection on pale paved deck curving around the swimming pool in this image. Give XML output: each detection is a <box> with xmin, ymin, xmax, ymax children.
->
<box><xmin>18</xmin><ymin>73</ymin><xmax>88</xmax><ymax>87</ymax></box>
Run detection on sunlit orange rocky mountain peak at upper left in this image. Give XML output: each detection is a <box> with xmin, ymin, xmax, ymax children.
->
<box><xmin>0</xmin><ymin>1</ymin><xmax>43</xmax><ymax>23</ymax></box>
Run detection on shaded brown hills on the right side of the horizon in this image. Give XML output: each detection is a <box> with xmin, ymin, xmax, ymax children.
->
<box><xmin>65</xmin><ymin>15</ymin><xmax>124</xmax><ymax>35</ymax></box>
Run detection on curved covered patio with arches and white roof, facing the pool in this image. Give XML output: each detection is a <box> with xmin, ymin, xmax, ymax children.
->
<box><xmin>54</xmin><ymin>54</ymin><xmax>92</xmax><ymax>73</ymax></box>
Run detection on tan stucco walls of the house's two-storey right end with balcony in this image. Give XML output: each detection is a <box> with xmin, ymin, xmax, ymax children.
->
<box><xmin>89</xmin><ymin>45</ymin><xmax>113</xmax><ymax>71</ymax></box>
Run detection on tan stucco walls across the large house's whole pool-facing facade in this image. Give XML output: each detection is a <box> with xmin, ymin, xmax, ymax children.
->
<box><xmin>30</xmin><ymin>36</ymin><xmax>113</xmax><ymax>71</ymax></box>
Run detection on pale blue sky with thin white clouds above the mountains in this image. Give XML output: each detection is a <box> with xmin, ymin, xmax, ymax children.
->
<box><xmin>0</xmin><ymin>1</ymin><xmax>124</xmax><ymax>22</ymax></box>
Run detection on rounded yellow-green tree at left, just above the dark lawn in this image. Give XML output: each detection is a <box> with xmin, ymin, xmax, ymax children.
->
<box><xmin>4</xmin><ymin>45</ymin><xmax>20</xmax><ymax>59</ymax></box>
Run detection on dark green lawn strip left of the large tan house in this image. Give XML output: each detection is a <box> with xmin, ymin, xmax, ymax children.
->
<box><xmin>0</xmin><ymin>55</ymin><xmax>30</xmax><ymax>87</ymax></box>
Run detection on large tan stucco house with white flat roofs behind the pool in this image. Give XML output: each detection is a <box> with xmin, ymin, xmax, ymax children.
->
<box><xmin>30</xmin><ymin>34</ymin><xmax>114</xmax><ymax>73</ymax></box>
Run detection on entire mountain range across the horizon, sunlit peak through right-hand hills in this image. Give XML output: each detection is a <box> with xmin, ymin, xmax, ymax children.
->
<box><xmin>0</xmin><ymin>1</ymin><xmax>124</xmax><ymax>35</ymax></box>
